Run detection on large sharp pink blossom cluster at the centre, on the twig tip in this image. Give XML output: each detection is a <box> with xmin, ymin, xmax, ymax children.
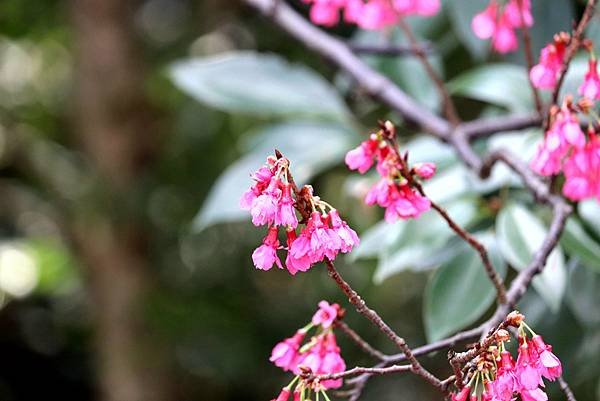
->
<box><xmin>240</xmin><ymin>152</ymin><xmax>359</xmax><ymax>274</ymax></box>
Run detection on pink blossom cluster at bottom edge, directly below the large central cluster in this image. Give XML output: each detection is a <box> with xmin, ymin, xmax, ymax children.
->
<box><xmin>270</xmin><ymin>301</ymin><xmax>346</xmax><ymax>401</ymax></box>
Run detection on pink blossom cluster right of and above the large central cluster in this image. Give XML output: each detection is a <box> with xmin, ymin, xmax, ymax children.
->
<box><xmin>346</xmin><ymin>121</ymin><xmax>436</xmax><ymax>222</ymax></box>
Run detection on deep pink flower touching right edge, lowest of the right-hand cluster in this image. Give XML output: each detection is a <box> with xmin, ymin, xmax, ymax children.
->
<box><xmin>563</xmin><ymin>135</ymin><xmax>600</xmax><ymax>201</ymax></box>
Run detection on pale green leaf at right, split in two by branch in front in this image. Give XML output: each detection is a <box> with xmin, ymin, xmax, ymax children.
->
<box><xmin>496</xmin><ymin>204</ymin><xmax>567</xmax><ymax>312</ymax></box>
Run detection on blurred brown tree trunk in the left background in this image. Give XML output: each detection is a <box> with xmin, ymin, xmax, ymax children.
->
<box><xmin>71</xmin><ymin>0</ymin><xmax>172</xmax><ymax>401</ymax></box>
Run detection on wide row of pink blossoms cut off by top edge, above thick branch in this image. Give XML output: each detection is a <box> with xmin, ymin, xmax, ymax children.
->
<box><xmin>304</xmin><ymin>0</ymin><xmax>440</xmax><ymax>29</ymax></box>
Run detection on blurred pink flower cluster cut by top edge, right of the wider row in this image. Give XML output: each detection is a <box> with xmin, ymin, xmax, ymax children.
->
<box><xmin>471</xmin><ymin>0</ymin><xmax>533</xmax><ymax>54</ymax></box>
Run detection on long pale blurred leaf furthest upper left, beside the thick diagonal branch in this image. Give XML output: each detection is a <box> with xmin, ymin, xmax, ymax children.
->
<box><xmin>169</xmin><ymin>51</ymin><xmax>349</xmax><ymax>121</ymax></box>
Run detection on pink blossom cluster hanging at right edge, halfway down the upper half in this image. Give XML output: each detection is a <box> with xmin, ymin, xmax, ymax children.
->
<box><xmin>531</xmin><ymin>96</ymin><xmax>600</xmax><ymax>201</ymax></box>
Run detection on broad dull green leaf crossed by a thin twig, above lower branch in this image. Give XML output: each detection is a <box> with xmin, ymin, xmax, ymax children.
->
<box><xmin>423</xmin><ymin>233</ymin><xmax>506</xmax><ymax>342</ymax></box>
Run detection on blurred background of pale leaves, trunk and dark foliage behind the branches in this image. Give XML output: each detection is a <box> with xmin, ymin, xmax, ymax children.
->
<box><xmin>0</xmin><ymin>0</ymin><xmax>600</xmax><ymax>401</ymax></box>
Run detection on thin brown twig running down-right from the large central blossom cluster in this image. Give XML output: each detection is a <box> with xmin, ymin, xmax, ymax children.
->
<box><xmin>325</xmin><ymin>259</ymin><xmax>441</xmax><ymax>389</ymax></box>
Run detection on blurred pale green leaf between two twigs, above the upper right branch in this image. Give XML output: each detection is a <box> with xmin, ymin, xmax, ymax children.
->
<box><xmin>448</xmin><ymin>64</ymin><xmax>533</xmax><ymax>111</ymax></box>
